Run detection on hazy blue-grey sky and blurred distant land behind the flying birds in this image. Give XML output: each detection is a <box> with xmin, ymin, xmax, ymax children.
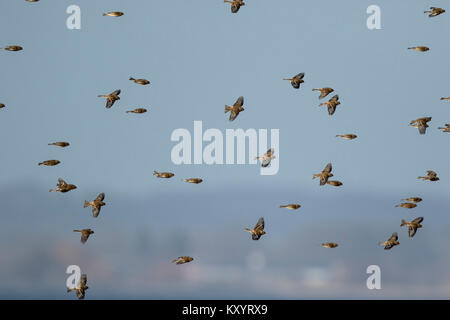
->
<box><xmin>0</xmin><ymin>0</ymin><xmax>450</xmax><ymax>299</ymax></box>
